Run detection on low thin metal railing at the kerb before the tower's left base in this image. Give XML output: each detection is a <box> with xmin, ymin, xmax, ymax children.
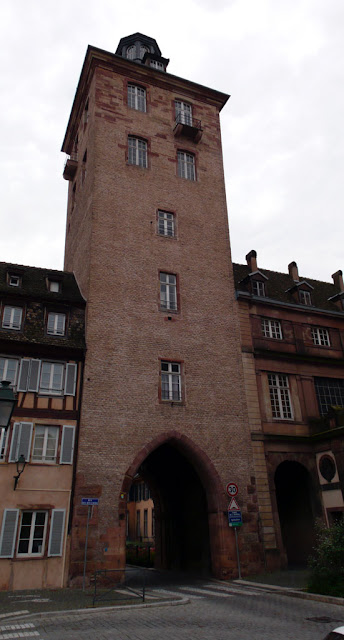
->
<box><xmin>93</xmin><ymin>567</ymin><xmax>146</xmax><ymax>606</ymax></box>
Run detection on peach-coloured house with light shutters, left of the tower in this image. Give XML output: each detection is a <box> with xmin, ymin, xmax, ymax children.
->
<box><xmin>0</xmin><ymin>262</ymin><xmax>85</xmax><ymax>590</ymax></box>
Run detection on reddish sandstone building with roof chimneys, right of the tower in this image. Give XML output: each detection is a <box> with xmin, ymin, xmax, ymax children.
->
<box><xmin>233</xmin><ymin>251</ymin><xmax>344</xmax><ymax>566</ymax></box>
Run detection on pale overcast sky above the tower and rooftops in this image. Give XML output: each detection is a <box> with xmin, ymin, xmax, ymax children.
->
<box><xmin>0</xmin><ymin>0</ymin><xmax>344</xmax><ymax>281</ymax></box>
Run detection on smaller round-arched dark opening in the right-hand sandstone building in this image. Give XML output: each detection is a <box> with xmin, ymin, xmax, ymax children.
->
<box><xmin>275</xmin><ymin>461</ymin><xmax>314</xmax><ymax>566</ymax></box>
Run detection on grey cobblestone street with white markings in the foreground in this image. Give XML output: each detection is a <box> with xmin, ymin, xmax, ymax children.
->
<box><xmin>0</xmin><ymin>582</ymin><xmax>344</xmax><ymax>640</ymax></box>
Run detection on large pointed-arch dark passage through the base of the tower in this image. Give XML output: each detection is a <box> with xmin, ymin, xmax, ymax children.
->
<box><xmin>123</xmin><ymin>434</ymin><xmax>231</xmax><ymax>575</ymax></box>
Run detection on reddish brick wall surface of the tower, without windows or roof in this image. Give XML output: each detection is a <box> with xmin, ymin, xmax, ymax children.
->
<box><xmin>65</xmin><ymin>57</ymin><xmax>264</xmax><ymax>577</ymax></box>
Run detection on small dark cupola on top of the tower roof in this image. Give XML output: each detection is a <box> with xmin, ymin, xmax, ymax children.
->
<box><xmin>116</xmin><ymin>33</ymin><xmax>169</xmax><ymax>71</ymax></box>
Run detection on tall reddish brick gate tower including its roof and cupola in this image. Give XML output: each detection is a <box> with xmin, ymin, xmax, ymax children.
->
<box><xmin>62</xmin><ymin>33</ymin><xmax>260</xmax><ymax>582</ymax></box>
